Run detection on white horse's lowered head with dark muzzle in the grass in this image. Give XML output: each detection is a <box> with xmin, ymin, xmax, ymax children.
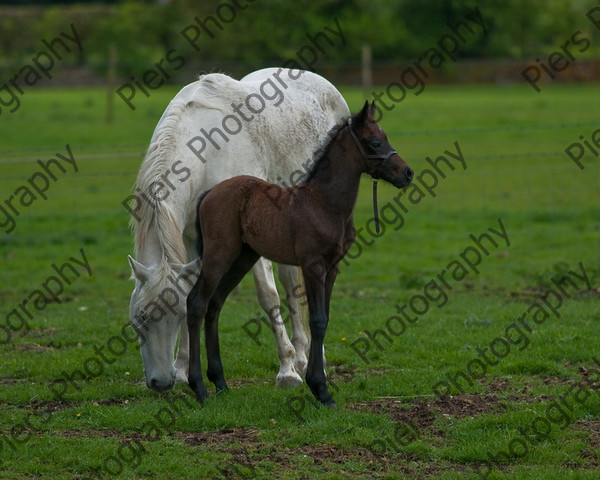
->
<box><xmin>129</xmin><ymin>257</ymin><xmax>199</xmax><ymax>392</ymax></box>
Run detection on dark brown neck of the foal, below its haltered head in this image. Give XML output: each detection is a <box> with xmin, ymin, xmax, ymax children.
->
<box><xmin>306</xmin><ymin>127</ymin><xmax>365</xmax><ymax>215</ymax></box>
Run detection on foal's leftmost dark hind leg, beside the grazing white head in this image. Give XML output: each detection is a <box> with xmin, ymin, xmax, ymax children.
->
<box><xmin>187</xmin><ymin>272</ymin><xmax>208</xmax><ymax>402</ymax></box>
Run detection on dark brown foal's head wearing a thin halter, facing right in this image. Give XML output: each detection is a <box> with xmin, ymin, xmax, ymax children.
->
<box><xmin>349</xmin><ymin>102</ymin><xmax>414</xmax><ymax>188</ymax></box>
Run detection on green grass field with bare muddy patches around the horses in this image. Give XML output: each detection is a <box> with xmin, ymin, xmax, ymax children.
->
<box><xmin>0</xmin><ymin>80</ymin><xmax>600</xmax><ymax>480</ymax></box>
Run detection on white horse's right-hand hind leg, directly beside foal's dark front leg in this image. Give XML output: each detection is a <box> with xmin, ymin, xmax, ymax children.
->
<box><xmin>277</xmin><ymin>264</ymin><xmax>308</xmax><ymax>375</ymax></box>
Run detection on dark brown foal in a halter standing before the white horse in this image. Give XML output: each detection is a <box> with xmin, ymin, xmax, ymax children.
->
<box><xmin>187</xmin><ymin>103</ymin><xmax>413</xmax><ymax>406</ymax></box>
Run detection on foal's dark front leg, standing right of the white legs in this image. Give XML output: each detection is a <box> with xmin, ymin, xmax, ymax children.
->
<box><xmin>302</xmin><ymin>261</ymin><xmax>335</xmax><ymax>407</ymax></box>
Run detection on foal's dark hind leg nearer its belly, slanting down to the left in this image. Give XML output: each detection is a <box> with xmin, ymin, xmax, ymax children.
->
<box><xmin>204</xmin><ymin>245</ymin><xmax>259</xmax><ymax>392</ymax></box>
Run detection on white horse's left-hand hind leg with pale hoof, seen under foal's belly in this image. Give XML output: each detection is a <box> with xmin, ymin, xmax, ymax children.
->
<box><xmin>252</xmin><ymin>258</ymin><xmax>302</xmax><ymax>387</ymax></box>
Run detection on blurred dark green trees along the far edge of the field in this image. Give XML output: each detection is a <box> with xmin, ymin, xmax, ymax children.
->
<box><xmin>0</xmin><ymin>0</ymin><xmax>600</xmax><ymax>80</ymax></box>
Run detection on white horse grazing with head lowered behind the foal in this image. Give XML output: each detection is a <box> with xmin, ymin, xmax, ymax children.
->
<box><xmin>124</xmin><ymin>68</ymin><xmax>350</xmax><ymax>391</ymax></box>
